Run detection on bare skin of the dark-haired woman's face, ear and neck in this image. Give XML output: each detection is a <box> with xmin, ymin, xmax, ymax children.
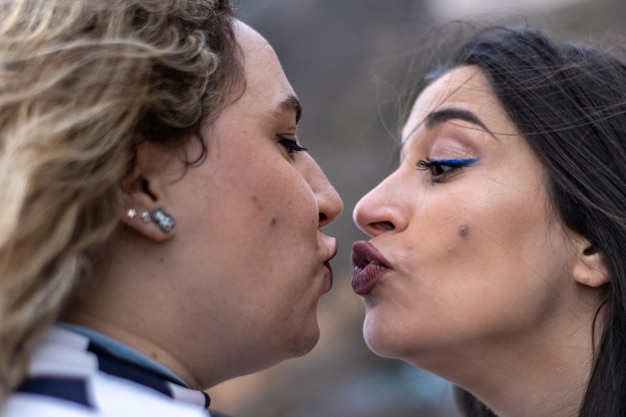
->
<box><xmin>354</xmin><ymin>66</ymin><xmax>607</xmax><ymax>417</ymax></box>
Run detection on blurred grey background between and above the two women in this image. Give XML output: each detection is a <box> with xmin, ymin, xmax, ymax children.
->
<box><xmin>210</xmin><ymin>0</ymin><xmax>626</xmax><ymax>417</ymax></box>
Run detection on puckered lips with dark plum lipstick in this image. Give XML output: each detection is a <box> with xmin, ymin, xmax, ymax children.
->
<box><xmin>352</xmin><ymin>240</ymin><xmax>393</xmax><ymax>295</ymax></box>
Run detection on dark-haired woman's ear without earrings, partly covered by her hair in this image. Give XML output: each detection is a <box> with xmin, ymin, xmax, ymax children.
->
<box><xmin>573</xmin><ymin>237</ymin><xmax>611</xmax><ymax>288</ymax></box>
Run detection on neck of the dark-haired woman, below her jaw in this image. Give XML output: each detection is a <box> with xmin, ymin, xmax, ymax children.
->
<box><xmin>424</xmin><ymin>311</ymin><xmax>602</xmax><ymax>417</ymax></box>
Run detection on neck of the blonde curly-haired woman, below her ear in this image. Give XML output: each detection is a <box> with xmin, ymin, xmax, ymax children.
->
<box><xmin>62</xmin><ymin>229</ymin><xmax>236</xmax><ymax>390</ymax></box>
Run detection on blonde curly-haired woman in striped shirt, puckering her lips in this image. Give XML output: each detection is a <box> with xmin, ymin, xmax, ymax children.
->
<box><xmin>0</xmin><ymin>0</ymin><xmax>342</xmax><ymax>416</ymax></box>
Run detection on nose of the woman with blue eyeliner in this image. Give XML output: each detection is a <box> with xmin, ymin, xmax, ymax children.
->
<box><xmin>352</xmin><ymin>172</ymin><xmax>409</xmax><ymax>237</ymax></box>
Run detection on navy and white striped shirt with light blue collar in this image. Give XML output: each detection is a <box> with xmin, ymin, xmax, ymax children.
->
<box><xmin>0</xmin><ymin>326</ymin><xmax>216</xmax><ymax>417</ymax></box>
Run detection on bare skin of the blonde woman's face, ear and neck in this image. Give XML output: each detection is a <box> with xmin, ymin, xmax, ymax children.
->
<box><xmin>66</xmin><ymin>23</ymin><xmax>343</xmax><ymax>389</ymax></box>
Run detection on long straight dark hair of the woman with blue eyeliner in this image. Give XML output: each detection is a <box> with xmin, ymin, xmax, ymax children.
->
<box><xmin>432</xmin><ymin>27</ymin><xmax>626</xmax><ymax>417</ymax></box>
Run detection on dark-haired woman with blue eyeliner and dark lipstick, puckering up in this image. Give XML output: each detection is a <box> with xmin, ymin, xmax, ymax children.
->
<box><xmin>352</xmin><ymin>28</ymin><xmax>626</xmax><ymax>417</ymax></box>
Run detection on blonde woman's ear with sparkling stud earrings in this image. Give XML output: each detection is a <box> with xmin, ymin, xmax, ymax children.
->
<box><xmin>121</xmin><ymin>141</ymin><xmax>175</xmax><ymax>242</ymax></box>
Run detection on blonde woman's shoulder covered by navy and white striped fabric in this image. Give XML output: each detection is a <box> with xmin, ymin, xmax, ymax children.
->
<box><xmin>7</xmin><ymin>329</ymin><xmax>209</xmax><ymax>417</ymax></box>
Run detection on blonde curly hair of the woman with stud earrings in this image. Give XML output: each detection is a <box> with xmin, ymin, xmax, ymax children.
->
<box><xmin>0</xmin><ymin>0</ymin><xmax>243</xmax><ymax>404</ymax></box>
